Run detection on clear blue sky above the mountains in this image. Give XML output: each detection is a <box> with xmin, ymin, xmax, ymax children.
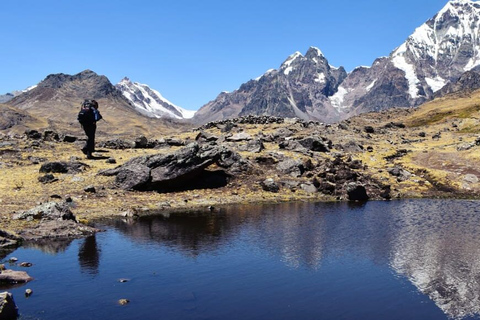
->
<box><xmin>0</xmin><ymin>0</ymin><xmax>447</xmax><ymax>110</ymax></box>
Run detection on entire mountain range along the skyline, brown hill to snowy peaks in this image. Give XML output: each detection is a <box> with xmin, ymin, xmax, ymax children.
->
<box><xmin>0</xmin><ymin>0</ymin><xmax>480</xmax><ymax>124</ymax></box>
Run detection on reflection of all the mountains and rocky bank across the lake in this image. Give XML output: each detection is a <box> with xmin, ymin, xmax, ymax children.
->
<box><xmin>103</xmin><ymin>200</ymin><xmax>480</xmax><ymax>318</ymax></box>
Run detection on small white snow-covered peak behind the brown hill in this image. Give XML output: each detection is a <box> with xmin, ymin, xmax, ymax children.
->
<box><xmin>115</xmin><ymin>77</ymin><xmax>195</xmax><ymax>119</ymax></box>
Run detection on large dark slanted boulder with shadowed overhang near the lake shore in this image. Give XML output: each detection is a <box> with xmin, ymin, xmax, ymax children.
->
<box><xmin>99</xmin><ymin>142</ymin><xmax>249</xmax><ymax>191</ymax></box>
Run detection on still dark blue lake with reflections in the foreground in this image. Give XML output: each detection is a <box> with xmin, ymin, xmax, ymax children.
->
<box><xmin>5</xmin><ymin>200</ymin><xmax>480</xmax><ymax>319</ymax></box>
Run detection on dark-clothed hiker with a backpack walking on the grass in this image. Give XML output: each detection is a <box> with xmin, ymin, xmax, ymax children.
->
<box><xmin>78</xmin><ymin>99</ymin><xmax>102</xmax><ymax>159</ymax></box>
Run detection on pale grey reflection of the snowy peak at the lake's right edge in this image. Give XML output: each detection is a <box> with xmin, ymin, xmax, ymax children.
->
<box><xmin>391</xmin><ymin>201</ymin><xmax>480</xmax><ymax>318</ymax></box>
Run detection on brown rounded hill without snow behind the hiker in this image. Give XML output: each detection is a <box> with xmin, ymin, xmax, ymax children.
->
<box><xmin>7</xmin><ymin>70</ymin><xmax>190</xmax><ymax>135</ymax></box>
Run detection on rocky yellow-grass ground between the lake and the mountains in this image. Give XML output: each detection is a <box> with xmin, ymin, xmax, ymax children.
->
<box><xmin>0</xmin><ymin>93</ymin><xmax>480</xmax><ymax>245</ymax></box>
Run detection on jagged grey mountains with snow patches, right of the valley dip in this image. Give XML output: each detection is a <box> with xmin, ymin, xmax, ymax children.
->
<box><xmin>194</xmin><ymin>0</ymin><xmax>480</xmax><ymax>123</ymax></box>
